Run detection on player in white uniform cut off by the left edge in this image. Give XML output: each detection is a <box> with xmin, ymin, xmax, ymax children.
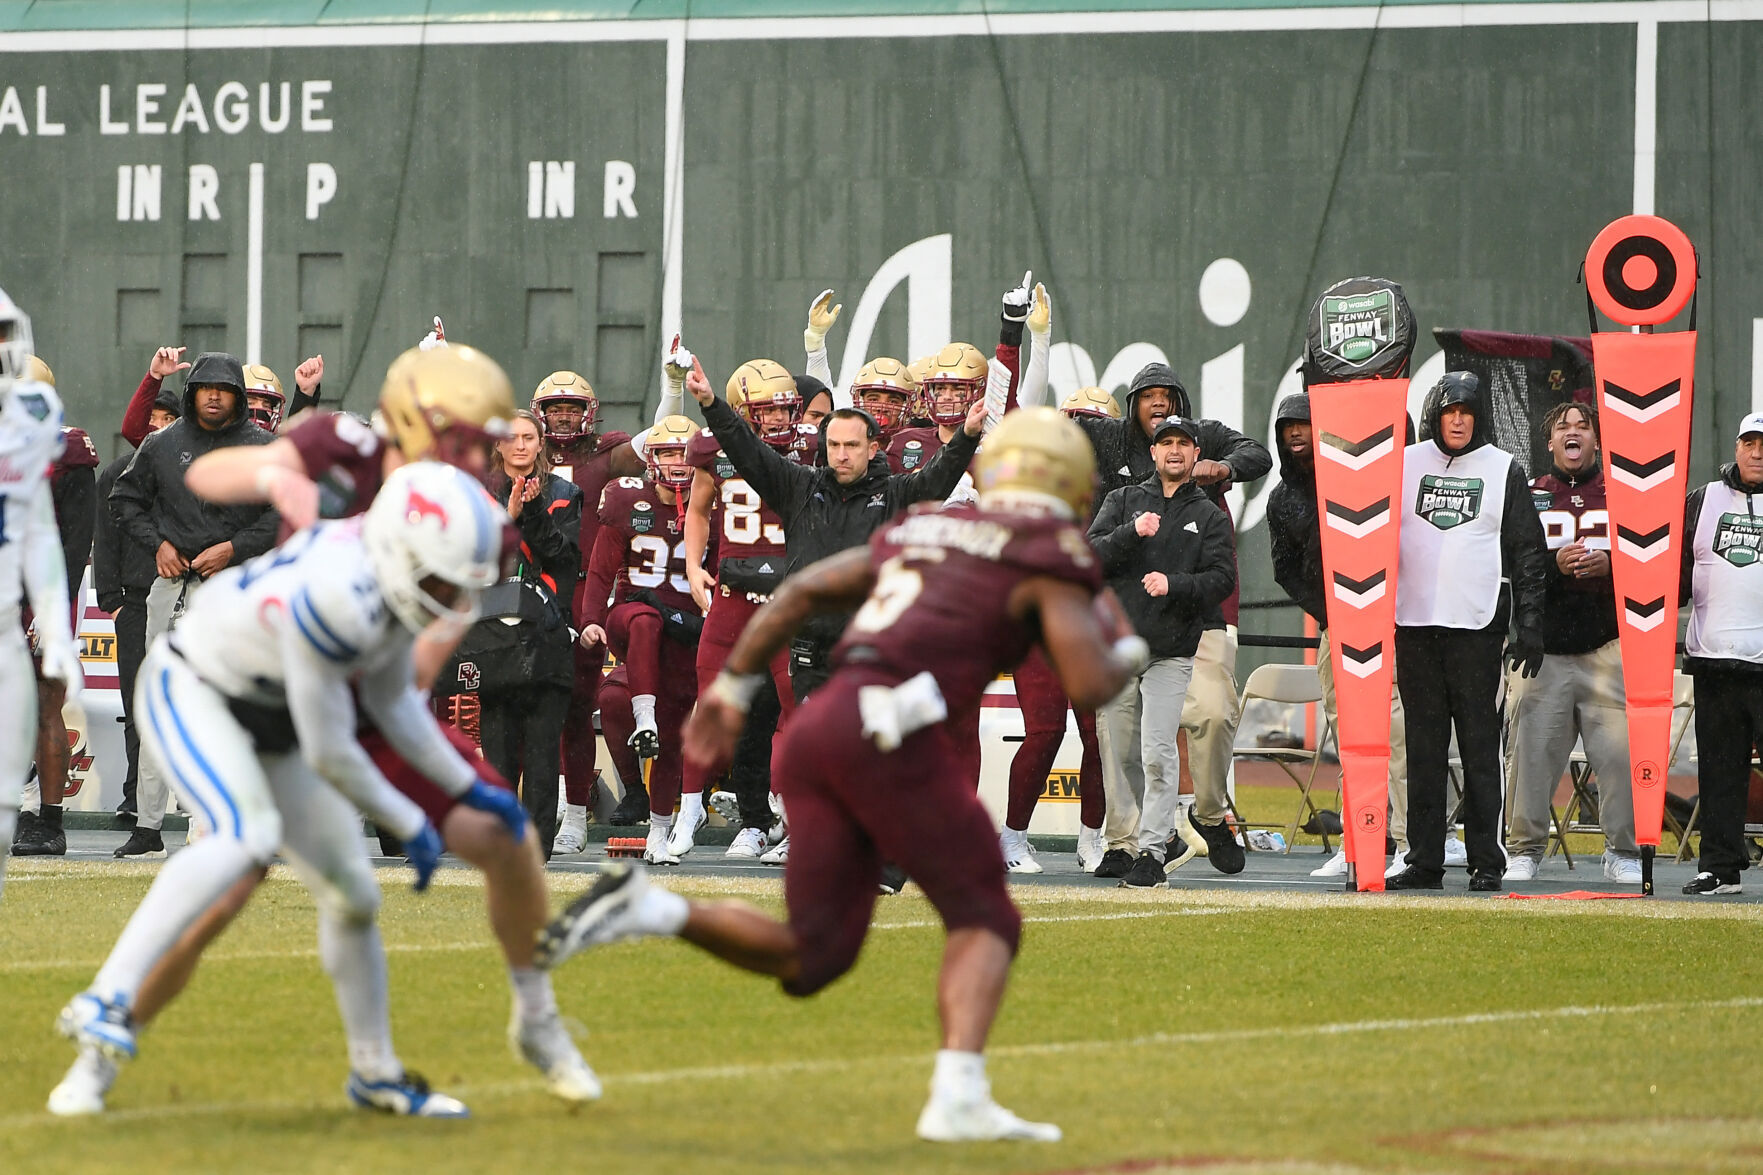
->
<box><xmin>0</xmin><ymin>289</ymin><xmax>81</xmax><ymax>893</ymax></box>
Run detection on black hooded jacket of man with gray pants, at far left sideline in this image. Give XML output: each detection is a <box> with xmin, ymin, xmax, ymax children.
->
<box><xmin>109</xmin><ymin>351</ymin><xmax>280</xmax><ymax>563</ymax></box>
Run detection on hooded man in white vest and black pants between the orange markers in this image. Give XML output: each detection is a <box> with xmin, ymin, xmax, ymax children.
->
<box><xmin>1387</xmin><ymin>370</ymin><xmax>1548</xmax><ymax>891</ymax></box>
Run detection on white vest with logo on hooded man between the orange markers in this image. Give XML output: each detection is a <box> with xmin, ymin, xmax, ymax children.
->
<box><xmin>1396</xmin><ymin>441</ymin><xmax>1513</xmax><ymax>628</ymax></box>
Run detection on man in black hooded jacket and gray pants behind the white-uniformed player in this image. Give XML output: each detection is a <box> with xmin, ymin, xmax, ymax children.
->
<box><xmin>109</xmin><ymin>351</ymin><xmax>280</xmax><ymax>857</ymax></box>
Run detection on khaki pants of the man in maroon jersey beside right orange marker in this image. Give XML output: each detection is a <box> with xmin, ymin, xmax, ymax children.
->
<box><xmin>1506</xmin><ymin>640</ymin><xmax>1640</xmax><ymax>861</ymax></box>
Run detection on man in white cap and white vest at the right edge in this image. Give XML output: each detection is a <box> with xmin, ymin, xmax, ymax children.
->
<box><xmin>1684</xmin><ymin>413</ymin><xmax>1763</xmax><ymax>894</ymax></box>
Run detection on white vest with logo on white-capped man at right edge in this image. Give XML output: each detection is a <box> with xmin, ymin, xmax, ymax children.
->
<box><xmin>1684</xmin><ymin>482</ymin><xmax>1763</xmax><ymax>663</ymax></box>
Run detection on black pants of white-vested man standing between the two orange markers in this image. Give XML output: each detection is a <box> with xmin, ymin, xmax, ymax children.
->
<box><xmin>1396</xmin><ymin>625</ymin><xmax>1506</xmax><ymax>877</ymax></box>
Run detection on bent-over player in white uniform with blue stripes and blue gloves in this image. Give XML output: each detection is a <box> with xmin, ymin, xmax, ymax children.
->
<box><xmin>49</xmin><ymin>462</ymin><xmax>511</xmax><ymax>1117</ymax></box>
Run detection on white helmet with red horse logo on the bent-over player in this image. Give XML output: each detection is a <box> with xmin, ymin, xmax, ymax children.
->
<box><xmin>361</xmin><ymin>460</ymin><xmax>508</xmax><ymax>632</ymax></box>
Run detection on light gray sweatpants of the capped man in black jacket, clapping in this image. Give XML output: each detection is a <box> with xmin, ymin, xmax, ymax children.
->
<box><xmin>1097</xmin><ymin>656</ymin><xmax>1194</xmax><ymax>861</ymax></box>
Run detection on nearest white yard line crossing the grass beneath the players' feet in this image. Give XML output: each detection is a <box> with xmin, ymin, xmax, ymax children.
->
<box><xmin>0</xmin><ymin>997</ymin><xmax>1763</xmax><ymax>1131</ymax></box>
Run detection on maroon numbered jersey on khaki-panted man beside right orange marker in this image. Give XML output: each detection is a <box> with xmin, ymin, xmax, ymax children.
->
<box><xmin>1530</xmin><ymin>466</ymin><xmax>1617</xmax><ymax>653</ymax></box>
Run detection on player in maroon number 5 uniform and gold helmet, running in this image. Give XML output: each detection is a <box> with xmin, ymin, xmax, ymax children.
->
<box><xmin>543</xmin><ymin>408</ymin><xmax>1148</xmax><ymax>1141</ymax></box>
